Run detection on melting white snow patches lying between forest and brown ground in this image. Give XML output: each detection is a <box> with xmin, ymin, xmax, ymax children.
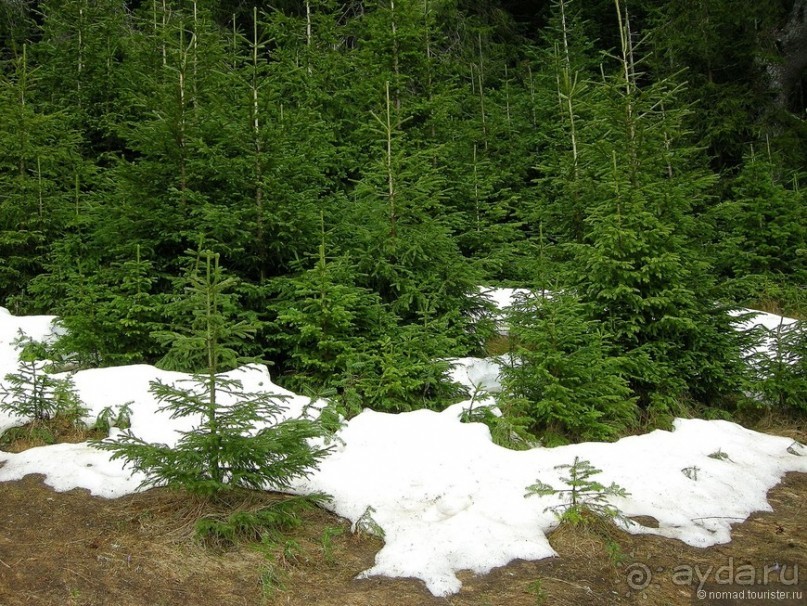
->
<box><xmin>0</xmin><ymin>308</ymin><xmax>807</xmax><ymax>595</ymax></box>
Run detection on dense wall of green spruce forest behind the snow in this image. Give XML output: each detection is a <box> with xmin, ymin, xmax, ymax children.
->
<box><xmin>0</xmin><ymin>0</ymin><xmax>807</xmax><ymax>442</ymax></box>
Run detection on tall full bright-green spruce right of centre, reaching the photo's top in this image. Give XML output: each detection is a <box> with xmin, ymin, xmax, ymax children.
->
<box><xmin>573</xmin><ymin>0</ymin><xmax>741</xmax><ymax>415</ymax></box>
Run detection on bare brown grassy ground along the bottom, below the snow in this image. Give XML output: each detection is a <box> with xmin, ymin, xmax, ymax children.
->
<box><xmin>0</xmin><ymin>426</ymin><xmax>807</xmax><ymax>606</ymax></box>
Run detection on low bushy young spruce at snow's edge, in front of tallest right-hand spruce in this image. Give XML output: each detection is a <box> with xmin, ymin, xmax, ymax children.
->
<box><xmin>498</xmin><ymin>294</ymin><xmax>637</xmax><ymax>442</ymax></box>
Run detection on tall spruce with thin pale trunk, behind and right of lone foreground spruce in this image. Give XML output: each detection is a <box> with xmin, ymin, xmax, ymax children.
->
<box><xmin>211</xmin><ymin>10</ymin><xmax>333</xmax><ymax>283</ymax></box>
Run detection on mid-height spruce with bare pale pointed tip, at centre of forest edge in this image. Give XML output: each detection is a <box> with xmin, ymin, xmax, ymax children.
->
<box><xmin>340</xmin><ymin>83</ymin><xmax>479</xmax><ymax>334</ymax></box>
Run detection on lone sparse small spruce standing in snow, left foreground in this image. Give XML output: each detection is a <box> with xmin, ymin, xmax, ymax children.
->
<box><xmin>99</xmin><ymin>251</ymin><xmax>325</xmax><ymax>536</ymax></box>
